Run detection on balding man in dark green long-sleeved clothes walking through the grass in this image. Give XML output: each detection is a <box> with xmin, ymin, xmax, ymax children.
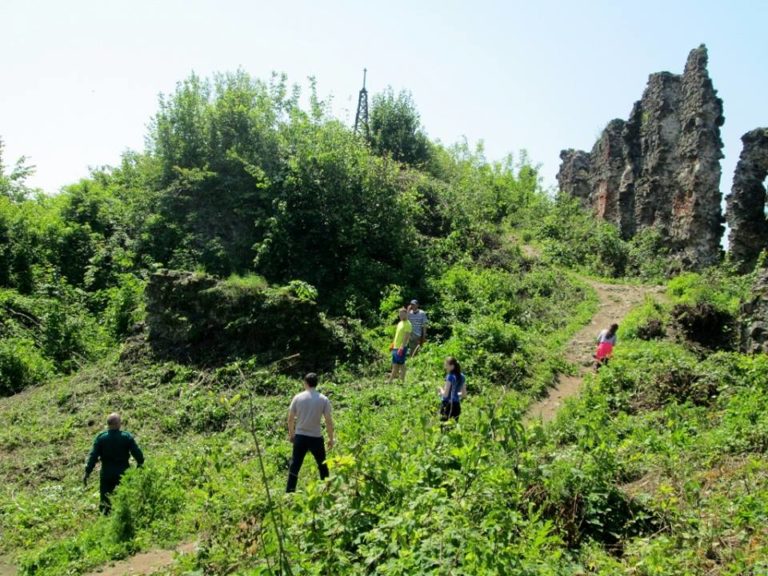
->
<box><xmin>83</xmin><ymin>412</ymin><xmax>144</xmax><ymax>515</ymax></box>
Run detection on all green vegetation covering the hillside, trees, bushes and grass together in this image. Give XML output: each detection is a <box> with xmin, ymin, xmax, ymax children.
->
<box><xmin>0</xmin><ymin>72</ymin><xmax>768</xmax><ymax>575</ymax></box>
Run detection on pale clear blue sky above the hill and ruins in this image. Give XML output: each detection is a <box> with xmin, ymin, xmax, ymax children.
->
<box><xmin>0</xmin><ymin>0</ymin><xmax>768</xmax><ymax>192</ymax></box>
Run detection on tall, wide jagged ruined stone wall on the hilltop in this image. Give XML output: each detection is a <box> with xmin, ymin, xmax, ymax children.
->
<box><xmin>558</xmin><ymin>46</ymin><xmax>724</xmax><ymax>268</ymax></box>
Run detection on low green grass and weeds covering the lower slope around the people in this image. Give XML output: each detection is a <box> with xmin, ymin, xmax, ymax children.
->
<box><xmin>6</xmin><ymin>270</ymin><xmax>768</xmax><ymax>576</ymax></box>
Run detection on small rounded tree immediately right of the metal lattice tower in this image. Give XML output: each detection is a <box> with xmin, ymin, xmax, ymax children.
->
<box><xmin>370</xmin><ymin>88</ymin><xmax>430</xmax><ymax>165</ymax></box>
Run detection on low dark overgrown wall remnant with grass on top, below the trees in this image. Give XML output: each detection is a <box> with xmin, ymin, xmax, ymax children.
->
<box><xmin>146</xmin><ymin>270</ymin><xmax>370</xmax><ymax>371</ymax></box>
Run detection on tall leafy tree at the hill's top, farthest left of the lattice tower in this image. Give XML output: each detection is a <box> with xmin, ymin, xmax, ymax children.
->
<box><xmin>144</xmin><ymin>71</ymin><xmax>295</xmax><ymax>276</ymax></box>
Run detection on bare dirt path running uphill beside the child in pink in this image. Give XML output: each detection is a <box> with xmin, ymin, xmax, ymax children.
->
<box><xmin>526</xmin><ymin>280</ymin><xmax>663</xmax><ymax>422</ymax></box>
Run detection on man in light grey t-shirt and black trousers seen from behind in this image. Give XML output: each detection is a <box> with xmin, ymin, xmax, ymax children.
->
<box><xmin>285</xmin><ymin>372</ymin><xmax>334</xmax><ymax>492</ymax></box>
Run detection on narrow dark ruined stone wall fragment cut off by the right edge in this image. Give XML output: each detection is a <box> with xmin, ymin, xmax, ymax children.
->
<box><xmin>726</xmin><ymin>128</ymin><xmax>768</xmax><ymax>271</ymax></box>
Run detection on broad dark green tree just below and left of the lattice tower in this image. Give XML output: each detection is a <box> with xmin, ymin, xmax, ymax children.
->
<box><xmin>256</xmin><ymin>117</ymin><xmax>415</xmax><ymax>314</ymax></box>
